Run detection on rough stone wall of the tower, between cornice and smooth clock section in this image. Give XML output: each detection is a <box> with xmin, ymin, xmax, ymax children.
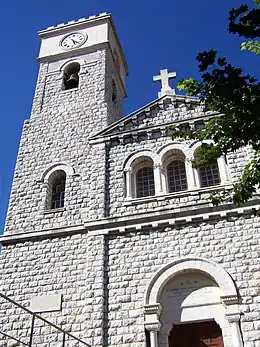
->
<box><xmin>5</xmin><ymin>50</ymin><xmax>122</xmax><ymax>234</ymax></box>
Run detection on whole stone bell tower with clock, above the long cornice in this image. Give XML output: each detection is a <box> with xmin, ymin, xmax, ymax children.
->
<box><xmin>2</xmin><ymin>13</ymin><xmax>127</xmax><ymax>235</ymax></box>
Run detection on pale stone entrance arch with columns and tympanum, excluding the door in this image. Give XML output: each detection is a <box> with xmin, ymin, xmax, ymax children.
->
<box><xmin>144</xmin><ymin>257</ymin><xmax>242</xmax><ymax>347</ymax></box>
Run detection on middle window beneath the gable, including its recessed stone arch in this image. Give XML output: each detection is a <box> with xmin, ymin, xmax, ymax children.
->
<box><xmin>163</xmin><ymin>149</ymin><xmax>188</xmax><ymax>193</ymax></box>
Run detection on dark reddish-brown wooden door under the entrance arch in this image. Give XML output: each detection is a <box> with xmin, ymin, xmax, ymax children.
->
<box><xmin>169</xmin><ymin>321</ymin><xmax>224</xmax><ymax>347</ymax></box>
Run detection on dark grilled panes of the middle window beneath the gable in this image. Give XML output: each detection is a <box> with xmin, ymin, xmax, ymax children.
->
<box><xmin>167</xmin><ymin>159</ymin><xmax>188</xmax><ymax>193</ymax></box>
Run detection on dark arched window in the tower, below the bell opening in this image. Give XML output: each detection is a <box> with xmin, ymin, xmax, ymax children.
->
<box><xmin>47</xmin><ymin>170</ymin><xmax>66</xmax><ymax>209</ymax></box>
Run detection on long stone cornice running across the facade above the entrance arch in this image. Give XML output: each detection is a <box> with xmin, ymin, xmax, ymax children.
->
<box><xmin>0</xmin><ymin>200</ymin><xmax>260</xmax><ymax>245</ymax></box>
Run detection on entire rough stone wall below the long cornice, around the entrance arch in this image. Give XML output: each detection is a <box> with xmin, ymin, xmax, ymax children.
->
<box><xmin>0</xmin><ymin>215</ymin><xmax>260</xmax><ymax>347</ymax></box>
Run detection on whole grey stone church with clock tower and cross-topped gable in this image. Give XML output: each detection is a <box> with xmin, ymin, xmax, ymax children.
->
<box><xmin>0</xmin><ymin>13</ymin><xmax>260</xmax><ymax>347</ymax></box>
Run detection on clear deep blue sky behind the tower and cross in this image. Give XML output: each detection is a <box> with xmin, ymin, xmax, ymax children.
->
<box><xmin>0</xmin><ymin>0</ymin><xmax>259</xmax><ymax>233</ymax></box>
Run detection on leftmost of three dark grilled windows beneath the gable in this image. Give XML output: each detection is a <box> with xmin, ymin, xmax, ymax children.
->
<box><xmin>136</xmin><ymin>166</ymin><xmax>155</xmax><ymax>198</ymax></box>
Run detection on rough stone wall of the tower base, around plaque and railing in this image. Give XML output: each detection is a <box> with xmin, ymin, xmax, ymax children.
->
<box><xmin>0</xmin><ymin>234</ymin><xmax>105</xmax><ymax>347</ymax></box>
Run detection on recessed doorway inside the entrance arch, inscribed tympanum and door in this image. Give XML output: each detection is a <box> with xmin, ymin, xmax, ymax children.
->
<box><xmin>158</xmin><ymin>269</ymin><xmax>226</xmax><ymax>347</ymax></box>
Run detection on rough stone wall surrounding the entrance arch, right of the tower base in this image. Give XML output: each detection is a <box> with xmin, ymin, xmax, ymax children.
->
<box><xmin>108</xmin><ymin>217</ymin><xmax>260</xmax><ymax>347</ymax></box>
